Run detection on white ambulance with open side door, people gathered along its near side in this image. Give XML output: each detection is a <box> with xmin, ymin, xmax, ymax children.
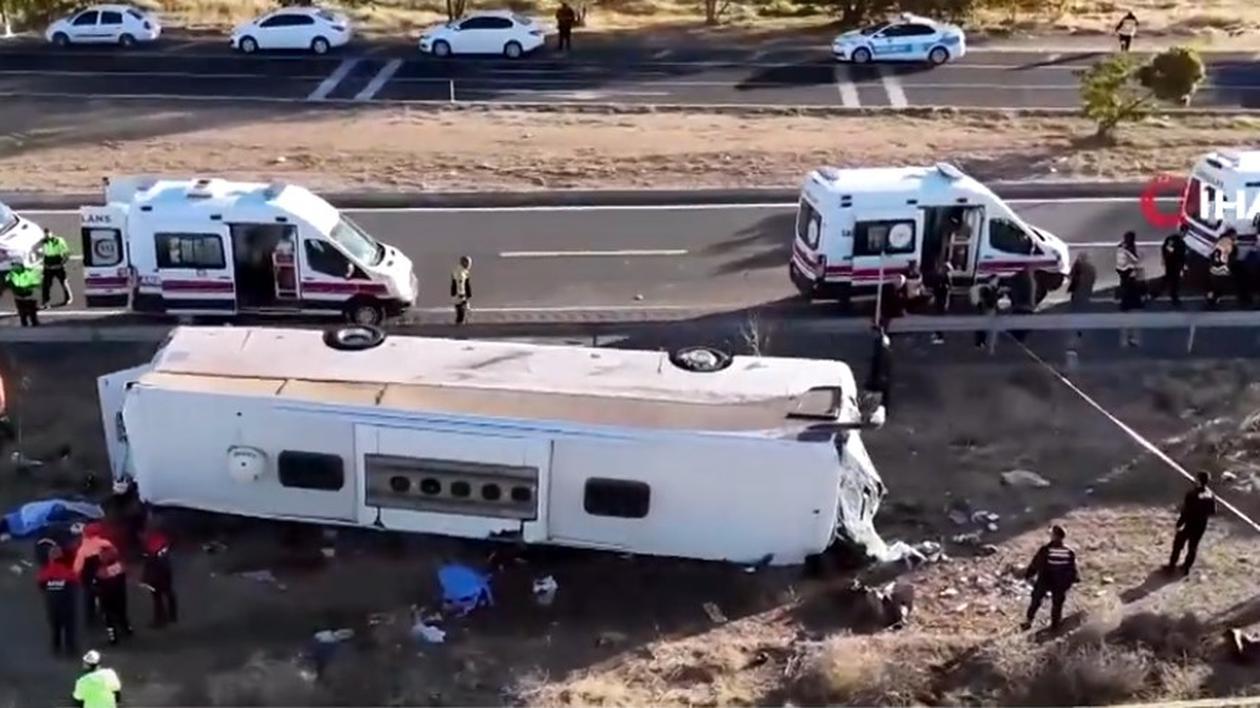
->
<box><xmin>789</xmin><ymin>164</ymin><xmax>1070</xmax><ymax>301</ymax></box>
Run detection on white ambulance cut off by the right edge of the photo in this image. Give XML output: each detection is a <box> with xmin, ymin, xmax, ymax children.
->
<box><xmin>1181</xmin><ymin>150</ymin><xmax>1260</xmax><ymax>258</ymax></box>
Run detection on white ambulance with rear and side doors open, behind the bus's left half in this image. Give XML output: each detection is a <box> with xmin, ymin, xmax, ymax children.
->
<box><xmin>79</xmin><ymin>178</ymin><xmax>417</xmax><ymax>324</ymax></box>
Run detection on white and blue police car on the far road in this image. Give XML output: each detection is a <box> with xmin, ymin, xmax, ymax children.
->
<box><xmin>832</xmin><ymin>14</ymin><xmax>966</xmax><ymax>64</ymax></box>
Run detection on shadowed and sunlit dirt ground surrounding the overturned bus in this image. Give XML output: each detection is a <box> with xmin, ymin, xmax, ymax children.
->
<box><xmin>0</xmin><ymin>333</ymin><xmax>1260</xmax><ymax>705</ymax></box>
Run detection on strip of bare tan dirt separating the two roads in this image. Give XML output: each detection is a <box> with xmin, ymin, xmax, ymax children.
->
<box><xmin>0</xmin><ymin>102</ymin><xmax>1260</xmax><ymax>191</ymax></box>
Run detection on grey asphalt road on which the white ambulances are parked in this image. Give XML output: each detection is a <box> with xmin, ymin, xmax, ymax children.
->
<box><xmin>5</xmin><ymin>199</ymin><xmax>1163</xmax><ymax>321</ymax></box>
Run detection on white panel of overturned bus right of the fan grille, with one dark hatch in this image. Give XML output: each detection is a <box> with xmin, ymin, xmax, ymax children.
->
<box><xmin>548</xmin><ymin>436</ymin><xmax>840</xmax><ymax>564</ymax></box>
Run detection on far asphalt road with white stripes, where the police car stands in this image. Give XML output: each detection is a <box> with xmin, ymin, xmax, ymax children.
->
<box><xmin>0</xmin><ymin>40</ymin><xmax>1260</xmax><ymax>108</ymax></box>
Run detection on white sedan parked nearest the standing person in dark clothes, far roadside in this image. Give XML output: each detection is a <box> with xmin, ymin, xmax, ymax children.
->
<box><xmin>420</xmin><ymin>10</ymin><xmax>547</xmax><ymax>59</ymax></box>
